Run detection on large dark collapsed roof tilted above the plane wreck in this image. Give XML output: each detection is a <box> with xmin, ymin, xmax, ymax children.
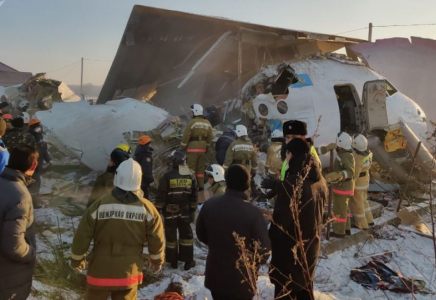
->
<box><xmin>97</xmin><ymin>5</ymin><xmax>362</xmax><ymax>115</ymax></box>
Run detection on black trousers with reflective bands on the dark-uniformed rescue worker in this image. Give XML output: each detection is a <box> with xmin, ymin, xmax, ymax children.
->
<box><xmin>165</xmin><ymin>216</ymin><xmax>194</xmax><ymax>264</ymax></box>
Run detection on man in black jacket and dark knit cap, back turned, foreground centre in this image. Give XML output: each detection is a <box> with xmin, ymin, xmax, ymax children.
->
<box><xmin>197</xmin><ymin>165</ymin><xmax>271</xmax><ymax>300</ymax></box>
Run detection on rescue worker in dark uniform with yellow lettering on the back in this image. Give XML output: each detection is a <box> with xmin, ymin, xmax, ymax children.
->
<box><xmin>155</xmin><ymin>150</ymin><xmax>198</xmax><ymax>271</ymax></box>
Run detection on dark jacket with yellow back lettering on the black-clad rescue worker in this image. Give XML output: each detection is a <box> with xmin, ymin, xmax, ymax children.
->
<box><xmin>154</xmin><ymin>166</ymin><xmax>198</xmax><ymax>219</ymax></box>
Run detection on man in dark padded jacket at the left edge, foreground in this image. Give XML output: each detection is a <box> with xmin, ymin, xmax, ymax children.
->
<box><xmin>0</xmin><ymin>145</ymin><xmax>38</xmax><ymax>300</ymax></box>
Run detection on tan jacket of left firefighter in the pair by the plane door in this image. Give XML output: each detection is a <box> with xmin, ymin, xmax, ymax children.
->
<box><xmin>332</xmin><ymin>148</ymin><xmax>355</xmax><ymax>196</ymax></box>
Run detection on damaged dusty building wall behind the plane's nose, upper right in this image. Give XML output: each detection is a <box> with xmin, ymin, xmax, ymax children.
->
<box><xmin>350</xmin><ymin>37</ymin><xmax>436</xmax><ymax>120</ymax></box>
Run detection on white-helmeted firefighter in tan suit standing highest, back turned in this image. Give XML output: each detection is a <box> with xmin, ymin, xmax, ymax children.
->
<box><xmin>180</xmin><ymin>104</ymin><xmax>213</xmax><ymax>191</ymax></box>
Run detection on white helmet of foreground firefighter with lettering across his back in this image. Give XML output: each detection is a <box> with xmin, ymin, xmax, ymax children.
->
<box><xmin>114</xmin><ymin>158</ymin><xmax>142</xmax><ymax>192</ymax></box>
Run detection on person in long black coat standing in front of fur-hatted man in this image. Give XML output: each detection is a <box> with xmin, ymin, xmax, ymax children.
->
<box><xmin>269</xmin><ymin>138</ymin><xmax>328</xmax><ymax>300</ymax></box>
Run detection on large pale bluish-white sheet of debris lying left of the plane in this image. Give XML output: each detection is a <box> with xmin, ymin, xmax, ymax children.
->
<box><xmin>36</xmin><ymin>98</ymin><xmax>169</xmax><ymax>171</ymax></box>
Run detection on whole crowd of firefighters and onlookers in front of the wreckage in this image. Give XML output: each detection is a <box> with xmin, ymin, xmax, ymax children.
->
<box><xmin>0</xmin><ymin>104</ymin><xmax>373</xmax><ymax>300</ymax></box>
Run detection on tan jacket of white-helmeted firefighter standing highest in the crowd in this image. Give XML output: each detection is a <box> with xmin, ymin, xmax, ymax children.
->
<box><xmin>180</xmin><ymin>116</ymin><xmax>213</xmax><ymax>153</ymax></box>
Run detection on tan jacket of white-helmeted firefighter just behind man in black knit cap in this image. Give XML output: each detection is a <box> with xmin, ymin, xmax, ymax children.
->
<box><xmin>223</xmin><ymin>136</ymin><xmax>257</xmax><ymax>174</ymax></box>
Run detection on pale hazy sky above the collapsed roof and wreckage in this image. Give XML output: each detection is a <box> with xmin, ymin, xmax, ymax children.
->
<box><xmin>0</xmin><ymin>0</ymin><xmax>436</xmax><ymax>85</ymax></box>
